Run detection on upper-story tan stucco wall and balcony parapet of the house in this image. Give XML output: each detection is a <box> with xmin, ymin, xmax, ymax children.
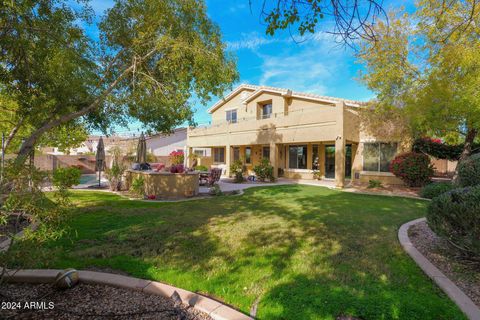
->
<box><xmin>187</xmin><ymin>93</ymin><xmax>348</xmax><ymax>147</ymax></box>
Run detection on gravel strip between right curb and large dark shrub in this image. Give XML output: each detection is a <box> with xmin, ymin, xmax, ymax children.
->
<box><xmin>408</xmin><ymin>222</ymin><xmax>480</xmax><ymax>307</ymax></box>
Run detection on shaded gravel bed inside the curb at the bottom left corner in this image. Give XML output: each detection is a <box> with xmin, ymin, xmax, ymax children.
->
<box><xmin>0</xmin><ymin>283</ymin><xmax>211</xmax><ymax>320</ymax></box>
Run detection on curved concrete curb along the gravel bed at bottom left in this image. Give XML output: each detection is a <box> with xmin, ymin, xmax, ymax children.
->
<box><xmin>2</xmin><ymin>269</ymin><xmax>253</xmax><ymax>320</ymax></box>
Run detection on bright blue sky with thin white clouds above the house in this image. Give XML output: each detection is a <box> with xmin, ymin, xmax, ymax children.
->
<box><xmin>85</xmin><ymin>0</ymin><xmax>411</xmax><ymax>132</ymax></box>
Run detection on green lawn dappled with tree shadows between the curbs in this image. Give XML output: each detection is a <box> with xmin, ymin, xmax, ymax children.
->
<box><xmin>8</xmin><ymin>185</ymin><xmax>465</xmax><ymax>320</ymax></box>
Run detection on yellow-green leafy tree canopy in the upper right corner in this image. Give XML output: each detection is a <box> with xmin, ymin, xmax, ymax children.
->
<box><xmin>359</xmin><ymin>0</ymin><xmax>480</xmax><ymax>160</ymax></box>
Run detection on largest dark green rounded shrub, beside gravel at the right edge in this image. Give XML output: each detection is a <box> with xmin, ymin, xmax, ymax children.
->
<box><xmin>427</xmin><ymin>186</ymin><xmax>480</xmax><ymax>261</ymax></box>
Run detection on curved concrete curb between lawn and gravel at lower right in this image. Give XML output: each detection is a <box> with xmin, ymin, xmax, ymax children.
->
<box><xmin>398</xmin><ymin>218</ymin><xmax>480</xmax><ymax>320</ymax></box>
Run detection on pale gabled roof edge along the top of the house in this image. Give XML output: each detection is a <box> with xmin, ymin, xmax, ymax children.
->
<box><xmin>207</xmin><ymin>83</ymin><xmax>365</xmax><ymax>113</ymax></box>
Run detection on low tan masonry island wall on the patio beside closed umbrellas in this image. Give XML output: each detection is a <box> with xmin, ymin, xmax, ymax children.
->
<box><xmin>125</xmin><ymin>170</ymin><xmax>199</xmax><ymax>199</ymax></box>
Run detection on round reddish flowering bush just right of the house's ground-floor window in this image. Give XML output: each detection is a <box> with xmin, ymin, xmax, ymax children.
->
<box><xmin>390</xmin><ymin>152</ymin><xmax>433</xmax><ymax>187</ymax></box>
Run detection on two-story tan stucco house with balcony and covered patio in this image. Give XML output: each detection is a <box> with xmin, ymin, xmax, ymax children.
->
<box><xmin>187</xmin><ymin>84</ymin><xmax>401</xmax><ymax>187</ymax></box>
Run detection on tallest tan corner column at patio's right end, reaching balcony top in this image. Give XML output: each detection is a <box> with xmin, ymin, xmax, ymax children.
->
<box><xmin>335</xmin><ymin>101</ymin><xmax>345</xmax><ymax>188</ymax></box>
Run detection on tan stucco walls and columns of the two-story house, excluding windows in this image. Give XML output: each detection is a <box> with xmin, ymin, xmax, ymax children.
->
<box><xmin>187</xmin><ymin>87</ymin><xmax>409</xmax><ymax>186</ymax></box>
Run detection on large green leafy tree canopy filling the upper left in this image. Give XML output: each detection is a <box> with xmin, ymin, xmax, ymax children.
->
<box><xmin>0</xmin><ymin>0</ymin><xmax>237</xmax><ymax>158</ymax></box>
